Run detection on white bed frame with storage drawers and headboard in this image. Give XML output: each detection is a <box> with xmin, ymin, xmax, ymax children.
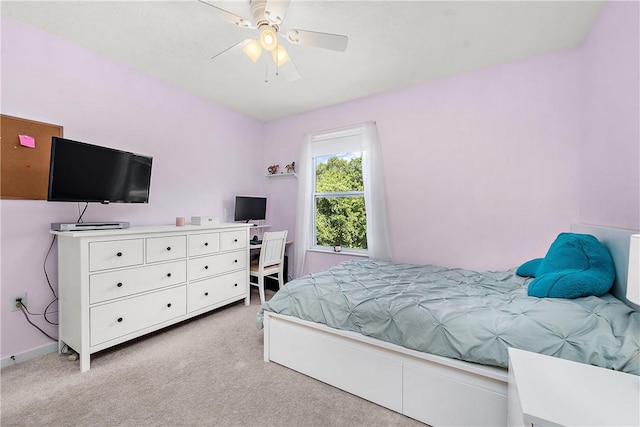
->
<box><xmin>264</xmin><ymin>224</ymin><xmax>637</xmax><ymax>426</ymax></box>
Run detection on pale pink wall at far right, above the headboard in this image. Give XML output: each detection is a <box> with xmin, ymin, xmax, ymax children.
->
<box><xmin>580</xmin><ymin>2</ymin><xmax>640</xmax><ymax>230</ymax></box>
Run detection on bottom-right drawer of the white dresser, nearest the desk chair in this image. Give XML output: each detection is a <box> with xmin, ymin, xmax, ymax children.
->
<box><xmin>187</xmin><ymin>271</ymin><xmax>248</xmax><ymax>312</ymax></box>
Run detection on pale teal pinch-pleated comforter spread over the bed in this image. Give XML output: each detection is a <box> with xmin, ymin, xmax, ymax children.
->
<box><xmin>257</xmin><ymin>260</ymin><xmax>640</xmax><ymax>375</ymax></box>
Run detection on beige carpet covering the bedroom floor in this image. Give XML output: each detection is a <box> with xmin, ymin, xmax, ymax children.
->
<box><xmin>0</xmin><ymin>290</ymin><xmax>423</xmax><ymax>426</ymax></box>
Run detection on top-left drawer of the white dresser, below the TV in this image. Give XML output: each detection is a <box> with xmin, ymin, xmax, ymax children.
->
<box><xmin>89</xmin><ymin>239</ymin><xmax>144</xmax><ymax>271</ymax></box>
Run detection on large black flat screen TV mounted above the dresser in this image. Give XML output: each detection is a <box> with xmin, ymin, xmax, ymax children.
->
<box><xmin>47</xmin><ymin>136</ymin><xmax>152</xmax><ymax>203</ymax></box>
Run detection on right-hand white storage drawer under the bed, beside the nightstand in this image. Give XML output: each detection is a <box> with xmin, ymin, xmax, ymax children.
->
<box><xmin>403</xmin><ymin>363</ymin><xmax>507</xmax><ymax>426</ymax></box>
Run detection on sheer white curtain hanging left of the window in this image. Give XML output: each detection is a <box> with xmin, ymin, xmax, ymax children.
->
<box><xmin>294</xmin><ymin>134</ymin><xmax>314</xmax><ymax>277</ymax></box>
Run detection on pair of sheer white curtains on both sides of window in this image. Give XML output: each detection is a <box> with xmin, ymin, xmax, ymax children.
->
<box><xmin>294</xmin><ymin>122</ymin><xmax>392</xmax><ymax>277</ymax></box>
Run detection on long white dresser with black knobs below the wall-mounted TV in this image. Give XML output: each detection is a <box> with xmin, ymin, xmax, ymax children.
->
<box><xmin>52</xmin><ymin>224</ymin><xmax>249</xmax><ymax>372</ymax></box>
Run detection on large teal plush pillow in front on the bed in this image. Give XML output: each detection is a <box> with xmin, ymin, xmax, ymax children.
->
<box><xmin>527</xmin><ymin>233</ymin><xmax>616</xmax><ymax>298</ymax></box>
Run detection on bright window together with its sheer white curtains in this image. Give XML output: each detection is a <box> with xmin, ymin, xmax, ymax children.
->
<box><xmin>294</xmin><ymin>122</ymin><xmax>392</xmax><ymax>277</ymax></box>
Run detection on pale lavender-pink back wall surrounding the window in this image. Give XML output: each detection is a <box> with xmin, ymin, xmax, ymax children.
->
<box><xmin>265</xmin><ymin>51</ymin><xmax>581</xmax><ymax>271</ymax></box>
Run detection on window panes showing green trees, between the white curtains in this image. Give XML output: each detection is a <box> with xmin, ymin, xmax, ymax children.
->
<box><xmin>311</xmin><ymin>129</ymin><xmax>367</xmax><ymax>254</ymax></box>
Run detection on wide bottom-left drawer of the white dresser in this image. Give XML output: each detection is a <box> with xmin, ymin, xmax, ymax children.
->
<box><xmin>89</xmin><ymin>285</ymin><xmax>187</xmax><ymax>346</ymax></box>
